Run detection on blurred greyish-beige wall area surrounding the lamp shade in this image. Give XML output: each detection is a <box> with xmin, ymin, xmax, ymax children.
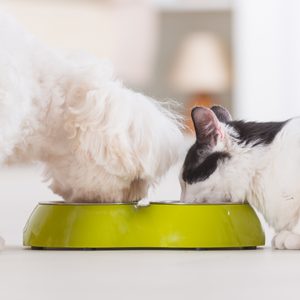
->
<box><xmin>149</xmin><ymin>11</ymin><xmax>232</xmax><ymax>111</ymax></box>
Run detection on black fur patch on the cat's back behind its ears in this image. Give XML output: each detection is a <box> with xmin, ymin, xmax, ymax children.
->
<box><xmin>227</xmin><ymin>121</ymin><xmax>288</xmax><ymax>146</ymax></box>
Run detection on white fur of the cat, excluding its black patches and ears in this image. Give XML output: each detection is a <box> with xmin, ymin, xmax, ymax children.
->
<box><xmin>180</xmin><ymin>106</ymin><xmax>300</xmax><ymax>249</ymax></box>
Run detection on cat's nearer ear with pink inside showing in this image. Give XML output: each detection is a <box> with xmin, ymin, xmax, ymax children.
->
<box><xmin>191</xmin><ymin>106</ymin><xmax>224</xmax><ymax>146</ymax></box>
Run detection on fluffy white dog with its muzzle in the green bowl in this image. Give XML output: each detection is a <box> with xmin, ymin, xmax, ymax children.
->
<box><xmin>0</xmin><ymin>14</ymin><xmax>182</xmax><ymax>209</ymax></box>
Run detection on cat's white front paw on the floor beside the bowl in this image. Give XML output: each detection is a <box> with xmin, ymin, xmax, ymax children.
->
<box><xmin>272</xmin><ymin>230</ymin><xmax>300</xmax><ymax>250</ymax></box>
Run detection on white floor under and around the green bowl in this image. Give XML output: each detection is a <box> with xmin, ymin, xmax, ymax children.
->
<box><xmin>0</xmin><ymin>161</ymin><xmax>300</xmax><ymax>300</ymax></box>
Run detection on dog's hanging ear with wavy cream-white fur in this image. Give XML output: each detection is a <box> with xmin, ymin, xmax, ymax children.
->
<box><xmin>64</xmin><ymin>85</ymin><xmax>137</xmax><ymax>176</ymax></box>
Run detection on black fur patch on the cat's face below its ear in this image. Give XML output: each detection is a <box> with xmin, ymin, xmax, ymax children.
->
<box><xmin>182</xmin><ymin>143</ymin><xmax>230</xmax><ymax>184</ymax></box>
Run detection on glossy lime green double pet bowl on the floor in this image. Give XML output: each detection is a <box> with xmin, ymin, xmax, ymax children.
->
<box><xmin>23</xmin><ymin>202</ymin><xmax>265</xmax><ymax>249</ymax></box>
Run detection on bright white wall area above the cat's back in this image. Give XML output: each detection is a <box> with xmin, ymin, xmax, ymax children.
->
<box><xmin>233</xmin><ymin>0</ymin><xmax>300</xmax><ymax>120</ymax></box>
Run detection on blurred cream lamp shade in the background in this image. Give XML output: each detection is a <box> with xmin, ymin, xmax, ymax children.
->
<box><xmin>171</xmin><ymin>33</ymin><xmax>229</xmax><ymax>94</ymax></box>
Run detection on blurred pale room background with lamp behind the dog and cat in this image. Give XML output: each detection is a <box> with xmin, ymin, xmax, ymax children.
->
<box><xmin>0</xmin><ymin>0</ymin><xmax>300</xmax><ymax>243</ymax></box>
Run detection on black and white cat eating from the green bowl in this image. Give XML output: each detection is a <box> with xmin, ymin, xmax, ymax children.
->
<box><xmin>180</xmin><ymin>106</ymin><xmax>300</xmax><ymax>249</ymax></box>
